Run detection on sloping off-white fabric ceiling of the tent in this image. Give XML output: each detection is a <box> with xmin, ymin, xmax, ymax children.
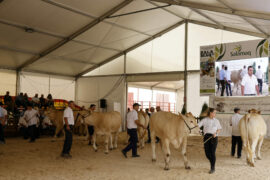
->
<box><xmin>0</xmin><ymin>0</ymin><xmax>270</xmax><ymax>76</ymax></box>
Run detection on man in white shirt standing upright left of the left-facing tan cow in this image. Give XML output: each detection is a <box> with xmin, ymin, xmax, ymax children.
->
<box><xmin>61</xmin><ymin>101</ymin><xmax>74</xmax><ymax>158</ymax></box>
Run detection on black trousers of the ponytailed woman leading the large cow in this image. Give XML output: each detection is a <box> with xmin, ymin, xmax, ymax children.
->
<box><xmin>203</xmin><ymin>134</ymin><xmax>218</xmax><ymax>170</ymax></box>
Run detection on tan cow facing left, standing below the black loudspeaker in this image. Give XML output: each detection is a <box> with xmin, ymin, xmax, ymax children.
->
<box><xmin>84</xmin><ymin>111</ymin><xmax>122</xmax><ymax>154</ymax></box>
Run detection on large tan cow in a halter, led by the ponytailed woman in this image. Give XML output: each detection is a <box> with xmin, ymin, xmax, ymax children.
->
<box><xmin>150</xmin><ymin>112</ymin><xmax>199</xmax><ymax>170</ymax></box>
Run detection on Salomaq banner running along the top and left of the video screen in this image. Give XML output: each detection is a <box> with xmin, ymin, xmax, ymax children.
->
<box><xmin>200</xmin><ymin>39</ymin><xmax>269</xmax><ymax>96</ymax></box>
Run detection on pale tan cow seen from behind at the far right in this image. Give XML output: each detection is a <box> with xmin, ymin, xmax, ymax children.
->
<box><xmin>239</xmin><ymin>109</ymin><xmax>267</xmax><ymax>167</ymax></box>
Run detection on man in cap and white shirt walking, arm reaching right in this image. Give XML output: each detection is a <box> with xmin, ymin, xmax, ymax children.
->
<box><xmin>122</xmin><ymin>103</ymin><xmax>147</xmax><ymax>158</ymax></box>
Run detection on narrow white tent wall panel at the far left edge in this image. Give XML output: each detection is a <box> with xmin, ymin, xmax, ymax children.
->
<box><xmin>0</xmin><ymin>70</ymin><xmax>16</xmax><ymax>96</ymax></box>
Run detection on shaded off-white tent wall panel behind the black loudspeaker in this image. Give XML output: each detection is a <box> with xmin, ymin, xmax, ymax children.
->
<box><xmin>76</xmin><ymin>76</ymin><xmax>126</xmax><ymax>129</ymax></box>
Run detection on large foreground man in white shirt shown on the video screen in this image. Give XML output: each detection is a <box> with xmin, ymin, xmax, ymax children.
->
<box><xmin>241</xmin><ymin>66</ymin><xmax>259</xmax><ymax>96</ymax></box>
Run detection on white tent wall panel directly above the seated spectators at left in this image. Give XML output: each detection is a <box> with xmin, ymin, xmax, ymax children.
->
<box><xmin>20</xmin><ymin>72</ymin><xmax>75</xmax><ymax>100</ymax></box>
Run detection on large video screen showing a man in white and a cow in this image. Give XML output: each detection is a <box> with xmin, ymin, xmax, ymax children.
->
<box><xmin>215</xmin><ymin>57</ymin><xmax>268</xmax><ymax>96</ymax></box>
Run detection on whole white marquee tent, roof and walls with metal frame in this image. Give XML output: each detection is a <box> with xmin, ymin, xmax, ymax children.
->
<box><xmin>0</xmin><ymin>0</ymin><xmax>270</xmax><ymax>119</ymax></box>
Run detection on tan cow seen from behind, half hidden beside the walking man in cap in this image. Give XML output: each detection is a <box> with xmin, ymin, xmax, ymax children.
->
<box><xmin>137</xmin><ymin>111</ymin><xmax>149</xmax><ymax>148</ymax></box>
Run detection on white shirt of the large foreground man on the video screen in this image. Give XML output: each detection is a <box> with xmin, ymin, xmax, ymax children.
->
<box><xmin>241</xmin><ymin>74</ymin><xmax>258</xmax><ymax>94</ymax></box>
